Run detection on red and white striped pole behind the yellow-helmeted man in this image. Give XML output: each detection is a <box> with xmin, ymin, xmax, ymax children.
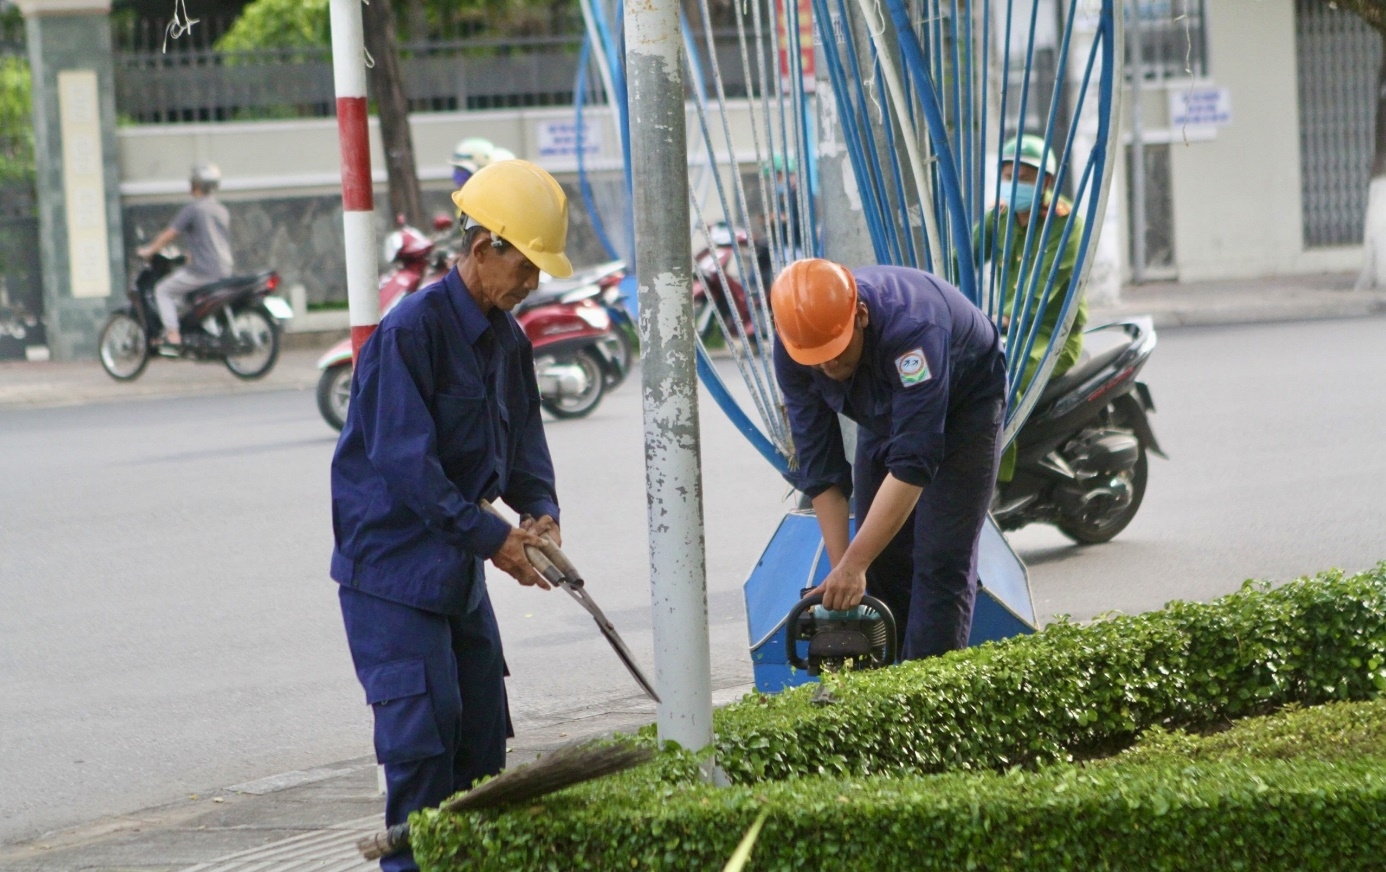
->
<box><xmin>330</xmin><ymin>0</ymin><xmax>380</xmax><ymax>360</ymax></box>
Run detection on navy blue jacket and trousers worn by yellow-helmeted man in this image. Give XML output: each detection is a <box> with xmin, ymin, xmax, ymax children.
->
<box><xmin>331</xmin><ymin>269</ymin><xmax>559</xmax><ymax>872</ymax></box>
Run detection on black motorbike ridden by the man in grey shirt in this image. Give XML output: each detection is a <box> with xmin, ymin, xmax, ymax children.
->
<box><xmin>98</xmin><ymin>247</ymin><xmax>294</xmax><ymax>381</ymax></box>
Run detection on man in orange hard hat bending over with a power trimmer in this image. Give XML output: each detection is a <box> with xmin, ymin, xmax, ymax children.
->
<box><xmin>771</xmin><ymin>259</ymin><xmax>1006</xmax><ymax>660</ymax></box>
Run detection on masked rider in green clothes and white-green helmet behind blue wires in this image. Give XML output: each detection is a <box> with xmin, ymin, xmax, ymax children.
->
<box><xmin>973</xmin><ymin>134</ymin><xmax>1088</xmax><ymax>482</ymax></box>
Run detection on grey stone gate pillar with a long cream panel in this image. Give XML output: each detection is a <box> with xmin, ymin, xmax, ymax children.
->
<box><xmin>18</xmin><ymin>0</ymin><xmax>125</xmax><ymax>360</ymax></box>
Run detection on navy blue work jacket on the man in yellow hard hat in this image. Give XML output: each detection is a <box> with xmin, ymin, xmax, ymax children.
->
<box><xmin>331</xmin><ymin>269</ymin><xmax>559</xmax><ymax>614</ymax></box>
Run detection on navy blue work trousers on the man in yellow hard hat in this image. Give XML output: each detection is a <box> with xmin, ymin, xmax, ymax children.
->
<box><xmin>341</xmin><ymin>585</ymin><xmax>513</xmax><ymax>872</ymax></box>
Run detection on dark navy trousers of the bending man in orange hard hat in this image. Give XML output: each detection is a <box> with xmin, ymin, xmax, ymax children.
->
<box><xmin>852</xmin><ymin>390</ymin><xmax>1006</xmax><ymax>660</ymax></box>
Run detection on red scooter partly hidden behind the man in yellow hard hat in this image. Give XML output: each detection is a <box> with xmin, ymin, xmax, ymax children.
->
<box><xmin>317</xmin><ymin>227</ymin><xmax>631</xmax><ymax>430</ymax></box>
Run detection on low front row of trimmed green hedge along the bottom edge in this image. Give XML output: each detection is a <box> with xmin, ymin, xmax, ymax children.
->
<box><xmin>413</xmin><ymin>701</ymin><xmax>1386</xmax><ymax>872</ymax></box>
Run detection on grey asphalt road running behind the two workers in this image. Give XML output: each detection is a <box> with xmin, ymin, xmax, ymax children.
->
<box><xmin>0</xmin><ymin>319</ymin><xmax>1386</xmax><ymax>842</ymax></box>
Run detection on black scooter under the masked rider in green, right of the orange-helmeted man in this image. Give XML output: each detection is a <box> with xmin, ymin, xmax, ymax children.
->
<box><xmin>992</xmin><ymin>317</ymin><xmax>1166</xmax><ymax>543</ymax></box>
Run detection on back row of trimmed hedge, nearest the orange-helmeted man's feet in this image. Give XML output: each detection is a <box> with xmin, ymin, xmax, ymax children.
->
<box><xmin>715</xmin><ymin>563</ymin><xmax>1386</xmax><ymax>783</ymax></box>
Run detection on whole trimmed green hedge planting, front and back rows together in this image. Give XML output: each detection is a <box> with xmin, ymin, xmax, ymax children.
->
<box><xmin>413</xmin><ymin>564</ymin><xmax>1386</xmax><ymax>871</ymax></box>
